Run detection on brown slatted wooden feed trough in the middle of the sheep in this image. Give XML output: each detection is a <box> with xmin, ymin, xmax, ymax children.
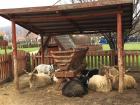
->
<box><xmin>51</xmin><ymin>47</ymin><xmax>88</xmax><ymax>78</ymax></box>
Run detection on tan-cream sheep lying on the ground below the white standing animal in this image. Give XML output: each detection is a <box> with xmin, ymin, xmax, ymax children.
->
<box><xmin>29</xmin><ymin>73</ymin><xmax>53</xmax><ymax>88</ymax></box>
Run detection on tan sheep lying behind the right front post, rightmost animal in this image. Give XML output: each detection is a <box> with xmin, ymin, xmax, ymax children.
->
<box><xmin>112</xmin><ymin>74</ymin><xmax>137</xmax><ymax>89</ymax></box>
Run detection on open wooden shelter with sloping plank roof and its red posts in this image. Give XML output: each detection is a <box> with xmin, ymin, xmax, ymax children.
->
<box><xmin>0</xmin><ymin>0</ymin><xmax>133</xmax><ymax>92</ymax></box>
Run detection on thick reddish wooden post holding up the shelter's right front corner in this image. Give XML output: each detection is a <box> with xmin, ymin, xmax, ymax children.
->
<box><xmin>117</xmin><ymin>12</ymin><xmax>124</xmax><ymax>93</ymax></box>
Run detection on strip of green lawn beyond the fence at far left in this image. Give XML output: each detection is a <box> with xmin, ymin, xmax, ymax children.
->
<box><xmin>0</xmin><ymin>47</ymin><xmax>39</xmax><ymax>54</ymax></box>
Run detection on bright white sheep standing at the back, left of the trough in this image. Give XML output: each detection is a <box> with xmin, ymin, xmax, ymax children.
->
<box><xmin>34</xmin><ymin>64</ymin><xmax>55</xmax><ymax>75</ymax></box>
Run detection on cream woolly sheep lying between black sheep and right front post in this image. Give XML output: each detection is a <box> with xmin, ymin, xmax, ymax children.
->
<box><xmin>88</xmin><ymin>71</ymin><xmax>112</xmax><ymax>92</ymax></box>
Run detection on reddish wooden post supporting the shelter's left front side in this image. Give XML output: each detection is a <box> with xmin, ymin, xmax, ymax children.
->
<box><xmin>12</xmin><ymin>21</ymin><xmax>19</xmax><ymax>90</ymax></box>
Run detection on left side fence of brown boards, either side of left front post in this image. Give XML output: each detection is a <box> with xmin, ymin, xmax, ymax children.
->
<box><xmin>0</xmin><ymin>51</ymin><xmax>30</xmax><ymax>83</ymax></box>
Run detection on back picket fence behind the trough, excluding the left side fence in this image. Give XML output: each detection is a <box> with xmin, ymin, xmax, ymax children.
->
<box><xmin>31</xmin><ymin>51</ymin><xmax>140</xmax><ymax>70</ymax></box>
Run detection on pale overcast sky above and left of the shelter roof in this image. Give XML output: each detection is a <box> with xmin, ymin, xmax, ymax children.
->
<box><xmin>0</xmin><ymin>0</ymin><xmax>69</xmax><ymax>27</ymax></box>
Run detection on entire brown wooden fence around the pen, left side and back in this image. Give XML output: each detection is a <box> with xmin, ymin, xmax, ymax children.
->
<box><xmin>0</xmin><ymin>51</ymin><xmax>140</xmax><ymax>83</ymax></box>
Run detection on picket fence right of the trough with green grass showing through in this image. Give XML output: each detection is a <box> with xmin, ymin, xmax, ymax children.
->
<box><xmin>86</xmin><ymin>50</ymin><xmax>140</xmax><ymax>70</ymax></box>
